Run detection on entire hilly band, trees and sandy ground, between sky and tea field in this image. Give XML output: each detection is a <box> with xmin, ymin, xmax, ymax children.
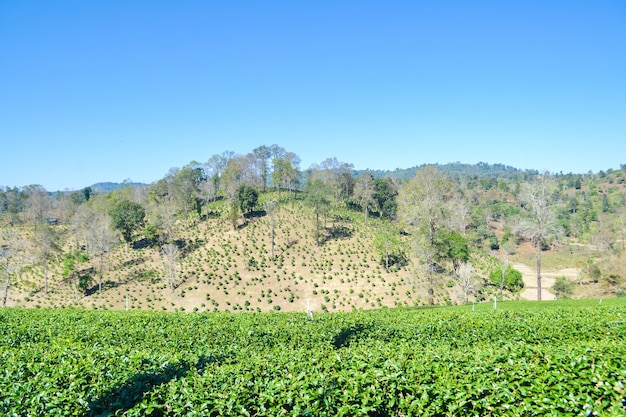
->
<box><xmin>0</xmin><ymin>145</ymin><xmax>626</xmax><ymax>311</ymax></box>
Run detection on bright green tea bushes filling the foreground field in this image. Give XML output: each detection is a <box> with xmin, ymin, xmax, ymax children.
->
<box><xmin>0</xmin><ymin>299</ymin><xmax>626</xmax><ymax>416</ymax></box>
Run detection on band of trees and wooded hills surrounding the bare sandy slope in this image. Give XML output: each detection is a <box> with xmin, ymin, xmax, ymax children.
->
<box><xmin>0</xmin><ymin>145</ymin><xmax>626</xmax><ymax>303</ymax></box>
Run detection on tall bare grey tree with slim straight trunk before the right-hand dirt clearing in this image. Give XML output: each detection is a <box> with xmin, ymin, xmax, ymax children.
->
<box><xmin>515</xmin><ymin>176</ymin><xmax>562</xmax><ymax>300</ymax></box>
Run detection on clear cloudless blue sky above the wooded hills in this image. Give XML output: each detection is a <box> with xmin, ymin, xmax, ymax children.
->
<box><xmin>0</xmin><ymin>0</ymin><xmax>626</xmax><ymax>190</ymax></box>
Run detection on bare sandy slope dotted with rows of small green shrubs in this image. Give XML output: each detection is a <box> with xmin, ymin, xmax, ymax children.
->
<box><xmin>4</xmin><ymin>201</ymin><xmax>458</xmax><ymax>311</ymax></box>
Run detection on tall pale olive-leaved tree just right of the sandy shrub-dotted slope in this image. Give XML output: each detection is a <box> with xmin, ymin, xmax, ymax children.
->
<box><xmin>398</xmin><ymin>165</ymin><xmax>454</xmax><ymax>305</ymax></box>
